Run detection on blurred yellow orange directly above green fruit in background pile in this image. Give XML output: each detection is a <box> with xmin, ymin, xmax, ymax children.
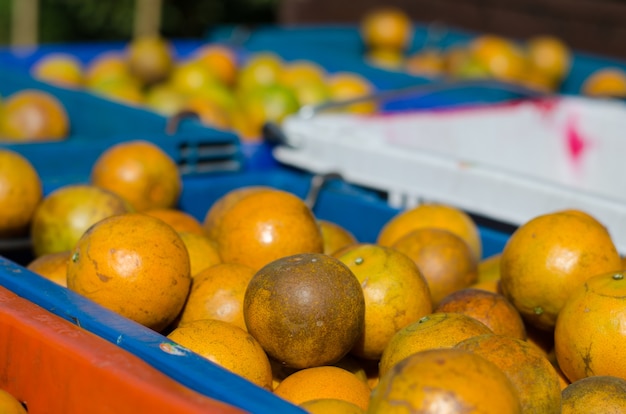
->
<box><xmin>236</xmin><ymin>51</ymin><xmax>285</xmax><ymax>92</ymax></box>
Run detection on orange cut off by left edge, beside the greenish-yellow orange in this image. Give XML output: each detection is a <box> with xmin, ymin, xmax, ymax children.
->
<box><xmin>0</xmin><ymin>148</ymin><xmax>43</xmax><ymax>239</ymax></box>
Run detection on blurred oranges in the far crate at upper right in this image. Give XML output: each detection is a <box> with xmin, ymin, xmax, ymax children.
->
<box><xmin>360</xmin><ymin>6</ymin><xmax>626</xmax><ymax>98</ymax></box>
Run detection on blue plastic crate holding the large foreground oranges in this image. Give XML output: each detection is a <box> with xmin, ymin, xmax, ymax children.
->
<box><xmin>0</xmin><ymin>169</ymin><xmax>509</xmax><ymax>414</ymax></box>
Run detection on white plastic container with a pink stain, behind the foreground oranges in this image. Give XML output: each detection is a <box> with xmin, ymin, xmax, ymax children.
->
<box><xmin>274</xmin><ymin>97</ymin><xmax>626</xmax><ymax>252</ymax></box>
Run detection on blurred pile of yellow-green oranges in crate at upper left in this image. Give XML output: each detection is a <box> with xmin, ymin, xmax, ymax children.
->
<box><xmin>31</xmin><ymin>36</ymin><xmax>376</xmax><ymax>141</ymax></box>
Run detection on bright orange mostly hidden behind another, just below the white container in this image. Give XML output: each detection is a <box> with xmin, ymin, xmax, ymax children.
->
<box><xmin>376</xmin><ymin>203</ymin><xmax>482</xmax><ymax>260</ymax></box>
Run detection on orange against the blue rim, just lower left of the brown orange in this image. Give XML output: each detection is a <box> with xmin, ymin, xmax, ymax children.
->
<box><xmin>167</xmin><ymin>319</ymin><xmax>272</xmax><ymax>390</ymax></box>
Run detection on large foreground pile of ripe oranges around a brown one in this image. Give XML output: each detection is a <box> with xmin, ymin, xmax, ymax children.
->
<box><xmin>0</xmin><ymin>131</ymin><xmax>626</xmax><ymax>413</ymax></box>
